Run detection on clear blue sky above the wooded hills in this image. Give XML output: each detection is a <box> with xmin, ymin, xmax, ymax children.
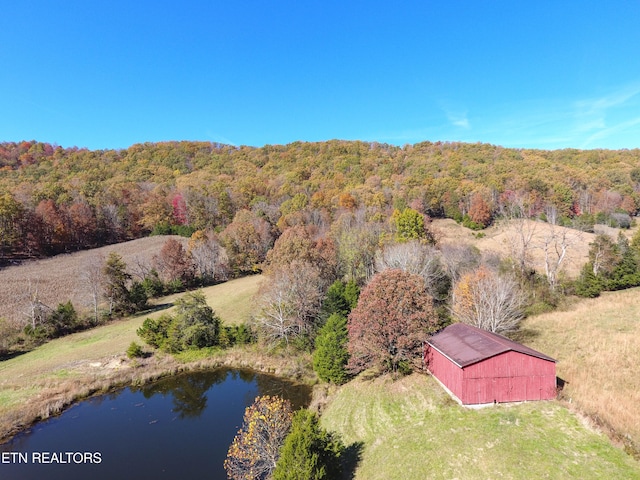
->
<box><xmin>0</xmin><ymin>0</ymin><xmax>640</xmax><ymax>149</ymax></box>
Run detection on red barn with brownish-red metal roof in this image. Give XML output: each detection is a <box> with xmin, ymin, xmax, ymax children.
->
<box><xmin>425</xmin><ymin>323</ymin><xmax>556</xmax><ymax>405</ymax></box>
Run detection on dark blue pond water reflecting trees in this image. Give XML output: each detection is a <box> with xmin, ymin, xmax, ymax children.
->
<box><xmin>0</xmin><ymin>369</ymin><xmax>311</xmax><ymax>480</ymax></box>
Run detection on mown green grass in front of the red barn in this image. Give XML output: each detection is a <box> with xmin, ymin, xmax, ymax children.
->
<box><xmin>321</xmin><ymin>374</ymin><xmax>640</xmax><ymax>480</ymax></box>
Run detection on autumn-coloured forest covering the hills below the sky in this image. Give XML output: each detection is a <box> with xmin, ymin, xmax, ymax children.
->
<box><xmin>0</xmin><ymin>141</ymin><xmax>640</xmax><ymax>264</ymax></box>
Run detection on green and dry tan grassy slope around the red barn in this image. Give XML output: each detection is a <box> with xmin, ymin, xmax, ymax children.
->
<box><xmin>322</xmin><ymin>289</ymin><xmax>640</xmax><ymax>479</ymax></box>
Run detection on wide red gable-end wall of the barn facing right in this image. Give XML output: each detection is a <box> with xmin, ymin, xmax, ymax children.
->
<box><xmin>459</xmin><ymin>351</ymin><xmax>556</xmax><ymax>404</ymax></box>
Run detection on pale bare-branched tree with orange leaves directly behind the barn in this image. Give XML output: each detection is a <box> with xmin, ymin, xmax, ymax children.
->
<box><xmin>451</xmin><ymin>266</ymin><xmax>526</xmax><ymax>333</ymax></box>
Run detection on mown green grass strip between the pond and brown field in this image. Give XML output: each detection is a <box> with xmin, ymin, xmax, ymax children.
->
<box><xmin>0</xmin><ymin>275</ymin><xmax>260</xmax><ymax>438</ymax></box>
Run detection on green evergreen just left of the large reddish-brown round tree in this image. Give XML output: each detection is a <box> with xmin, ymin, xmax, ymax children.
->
<box><xmin>313</xmin><ymin>313</ymin><xmax>349</xmax><ymax>385</ymax></box>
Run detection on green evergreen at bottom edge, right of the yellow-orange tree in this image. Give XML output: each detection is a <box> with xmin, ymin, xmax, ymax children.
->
<box><xmin>272</xmin><ymin>409</ymin><xmax>345</xmax><ymax>480</ymax></box>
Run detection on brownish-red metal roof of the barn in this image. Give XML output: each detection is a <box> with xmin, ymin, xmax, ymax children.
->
<box><xmin>428</xmin><ymin>323</ymin><xmax>555</xmax><ymax>368</ymax></box>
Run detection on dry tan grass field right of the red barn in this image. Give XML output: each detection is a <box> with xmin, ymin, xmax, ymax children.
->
<box><xmin>522</xmin><ymin>288</ymin><xmax>640</xmax><ymax>448</ymax></box>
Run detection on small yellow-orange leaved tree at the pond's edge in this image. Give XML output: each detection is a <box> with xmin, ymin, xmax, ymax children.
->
<box><xmin>224</xmin><ymin>395</ymin><xmax>293</xmax><ymax>480</ymax></box>
